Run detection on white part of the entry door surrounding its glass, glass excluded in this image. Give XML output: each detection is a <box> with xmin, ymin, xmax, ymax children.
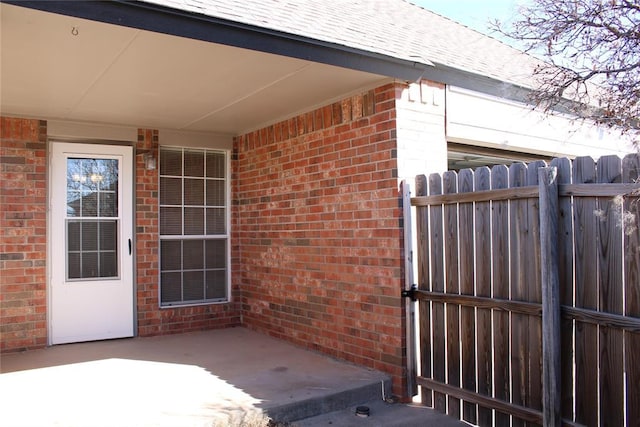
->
<box><xmin>47</xmin><ymin>141</ymin><xmax>136</xmax><ymax>345</ymax></box>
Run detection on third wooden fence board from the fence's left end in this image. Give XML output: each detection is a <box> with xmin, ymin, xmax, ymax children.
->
<box><xmin>443</xmin><ymin>172</ymin><xmax>460</xmax><ymax>419</ymax></box>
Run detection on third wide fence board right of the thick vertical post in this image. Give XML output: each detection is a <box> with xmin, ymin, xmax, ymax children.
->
<box><xmin>596</xmin><ymin>156</ymin><xmax>624</xmax><ymax>426</ymax></box>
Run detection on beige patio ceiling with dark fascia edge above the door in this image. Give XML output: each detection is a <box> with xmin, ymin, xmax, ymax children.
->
<box><xmin>0</xmin><ymin>1</ymin><xmax>400</xmax><ymax>135</ymax></box>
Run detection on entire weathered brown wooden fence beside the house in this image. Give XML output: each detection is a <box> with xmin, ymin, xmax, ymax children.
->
<box><xmin>411</xmin><ymin>155</ymin><xmax>640</xmax><ymax>426</ymax></box>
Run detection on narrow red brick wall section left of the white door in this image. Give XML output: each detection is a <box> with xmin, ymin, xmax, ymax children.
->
<box><xmin>0</xmin><ymin>117</ymin><xmax>47</xmax><ymax>351</ymax></box>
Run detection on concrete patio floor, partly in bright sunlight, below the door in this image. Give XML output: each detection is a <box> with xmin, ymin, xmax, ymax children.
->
<box><xmin>0</xmin><ymin>328</ymin><xmax>388</xmax><ymax>427</ymax></box>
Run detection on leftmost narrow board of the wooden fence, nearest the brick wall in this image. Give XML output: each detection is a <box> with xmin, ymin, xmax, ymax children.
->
<box><xmin>416</xmin><ymin>175</ymin><xmax>433</xmax><ymax>406</ymax></box>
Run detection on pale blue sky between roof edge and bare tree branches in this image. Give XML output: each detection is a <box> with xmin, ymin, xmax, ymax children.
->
<box><xmin>409</xmin><ymin>0</ymin><xmax>526</xmax><ymax>36</ymax></box>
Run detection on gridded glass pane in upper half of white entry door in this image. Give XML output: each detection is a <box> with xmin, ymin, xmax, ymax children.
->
<box><xmin>66</xmin><ymin>158</ymin><xmax>119</xmax><ymax>280</ymax></box>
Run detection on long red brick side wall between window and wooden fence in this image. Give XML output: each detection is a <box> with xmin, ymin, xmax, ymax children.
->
<box><xmin>233</xmin><ymin>84</ymin><xmax>405</xmax><ymax>394</ymax></box>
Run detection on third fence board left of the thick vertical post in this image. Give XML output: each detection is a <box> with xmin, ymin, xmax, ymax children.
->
<box><xmin>491</xmin><ymin>165</ymin><xmax>511</xmax><ymax>427</ymax></box>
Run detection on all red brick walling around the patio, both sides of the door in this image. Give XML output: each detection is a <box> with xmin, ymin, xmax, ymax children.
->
<box><xmin>0</xmin><ymin>84</ymin><xmax>416</xmax><ymax>394</ymax></box>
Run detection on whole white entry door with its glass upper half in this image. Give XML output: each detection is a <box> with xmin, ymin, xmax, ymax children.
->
<box><xmin>49</xmin><ymin>142</ymin><xmax>134</xmax><ymax>344</ymax></box>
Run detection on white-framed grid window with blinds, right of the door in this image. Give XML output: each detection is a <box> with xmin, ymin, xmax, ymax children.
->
<box><xmin>160</xmin><ymin>148</ymin><xmax>229</xmax><ymax>306</ymax></box>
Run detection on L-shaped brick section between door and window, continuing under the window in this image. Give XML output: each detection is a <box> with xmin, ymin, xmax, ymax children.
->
<box><xmin>135</xmin><ymin>129</ymin><xmax>240</xmax><ymax>336</ymax></box>
